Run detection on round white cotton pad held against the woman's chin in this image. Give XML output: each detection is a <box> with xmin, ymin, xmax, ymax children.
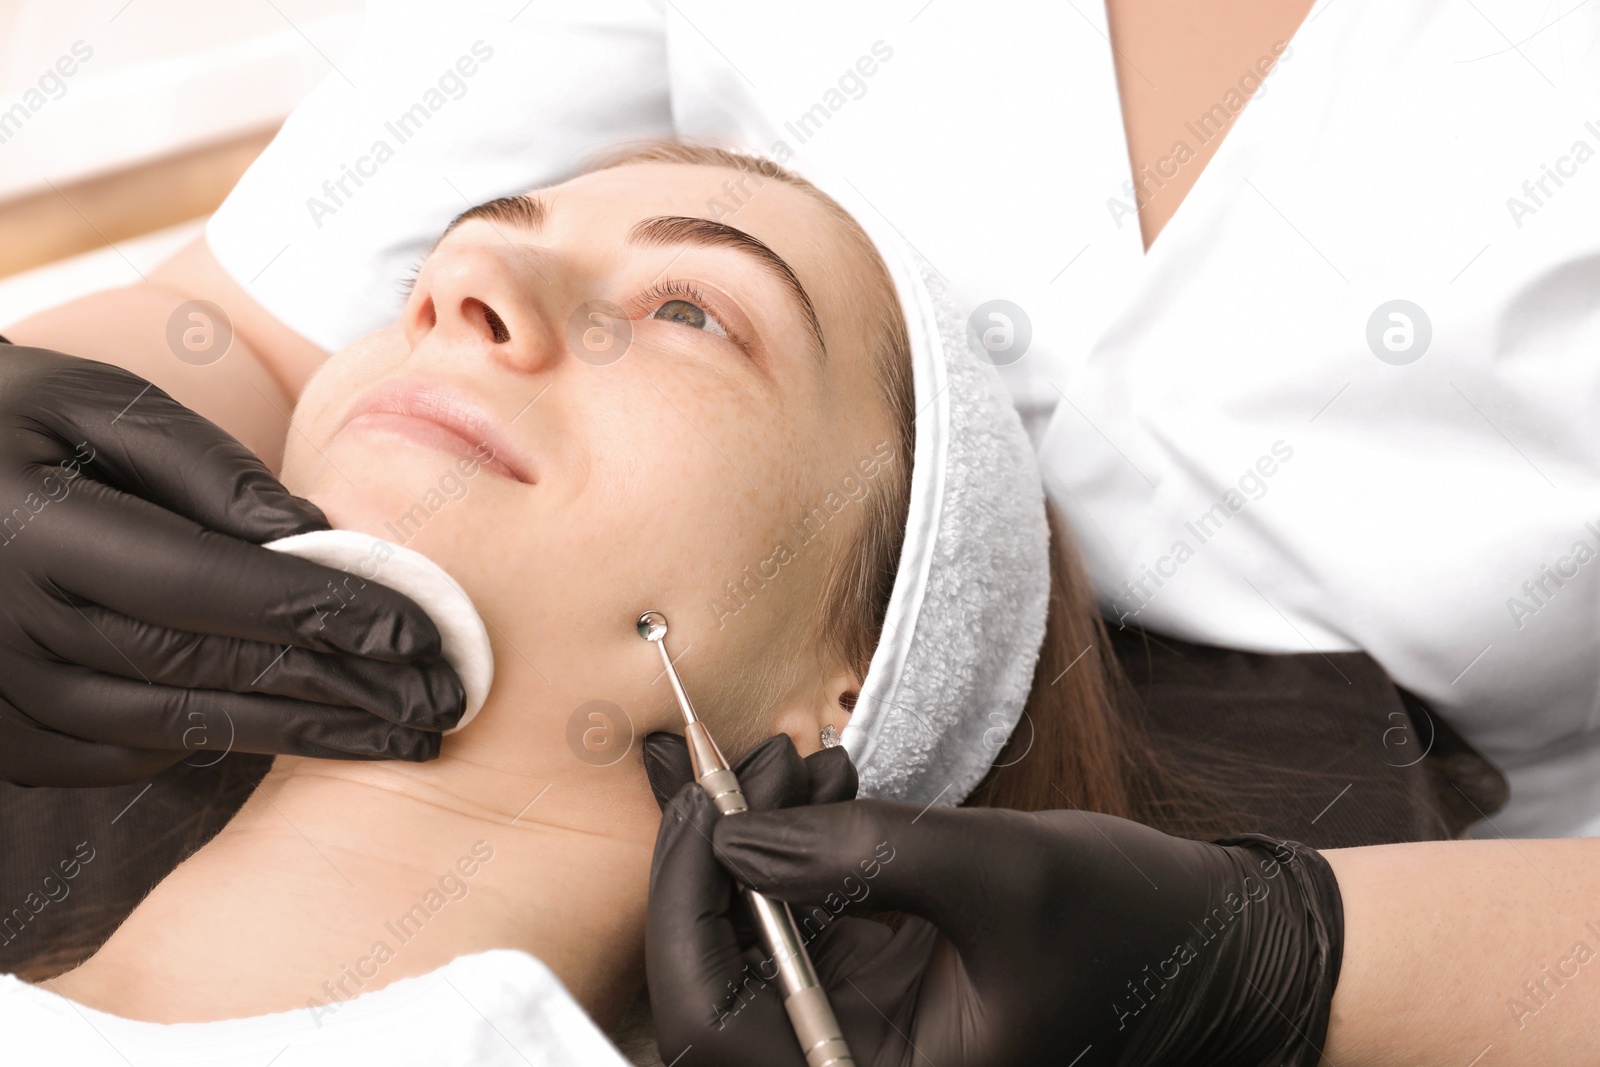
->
<box><xmin>261</xmin><ymin>530</ymin><xmax>494</xmax><ymax>734</ymax></box>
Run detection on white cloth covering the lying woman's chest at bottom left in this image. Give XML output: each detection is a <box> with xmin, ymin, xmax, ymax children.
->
<box><xmin>0</xmin><ymin>949</ymin><xmax>627</xmax><ymax>1067</ymax></box>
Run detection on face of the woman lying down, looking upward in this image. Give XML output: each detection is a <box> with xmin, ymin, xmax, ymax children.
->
<box><xmin>283</xmin><ymin>163</ymin><xmax>906</xmax><ymax>758</ymax></box>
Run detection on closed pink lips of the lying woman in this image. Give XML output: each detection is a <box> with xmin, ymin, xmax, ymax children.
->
<box><xmin>344</xmin><ymin>382</ymin><xmax>534</xmax><ymax>485</ymax></box>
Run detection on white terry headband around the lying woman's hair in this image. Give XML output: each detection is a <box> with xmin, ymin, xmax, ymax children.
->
<box><xmin>806</xmin><ymin>171</ymin><xmax>1050</xmax><ymax>805</ymax></box>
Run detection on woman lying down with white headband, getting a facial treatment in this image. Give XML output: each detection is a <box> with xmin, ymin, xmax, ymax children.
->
<box><xmin>0</xmin><ymin>146</ymin><xmax>1273</xmax><ymax>1065</ymax></box>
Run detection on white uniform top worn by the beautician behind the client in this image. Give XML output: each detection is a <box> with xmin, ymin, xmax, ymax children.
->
<box><xmin>206</xmin><ymin>0</ymin><xmax>1600</xmax><ymax>835</ymax></box>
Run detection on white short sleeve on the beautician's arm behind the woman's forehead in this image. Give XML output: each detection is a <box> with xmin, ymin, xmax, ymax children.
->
<box><xmin>206</xmin><ymin>0</ymin><xmax>672</xmax><ymax>352</ymax></box>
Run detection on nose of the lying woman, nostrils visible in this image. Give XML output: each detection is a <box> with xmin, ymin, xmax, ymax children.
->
<box><xmin>400</xmin><ymin>245</ymin><xmax>562</xmax><ymax>371</ymax></box>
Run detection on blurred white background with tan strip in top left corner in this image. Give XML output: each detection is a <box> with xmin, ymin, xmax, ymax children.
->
<box><xmin>0</xmin><ymin>0</ymin><xmax>362</xmax><ymax>323</ymax></box>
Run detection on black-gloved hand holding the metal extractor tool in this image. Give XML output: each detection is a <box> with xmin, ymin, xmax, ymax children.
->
<box><xmin>645</xmin><ymin>735</ymin><xmax>1344</xmax><ymax>1067</ymax></box>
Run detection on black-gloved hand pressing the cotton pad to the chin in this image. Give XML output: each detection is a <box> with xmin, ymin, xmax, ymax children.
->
<box><xmin>0</xmin><ymin>346</ymin><xmax>464</xmax><ymax>785</ymax></box>
